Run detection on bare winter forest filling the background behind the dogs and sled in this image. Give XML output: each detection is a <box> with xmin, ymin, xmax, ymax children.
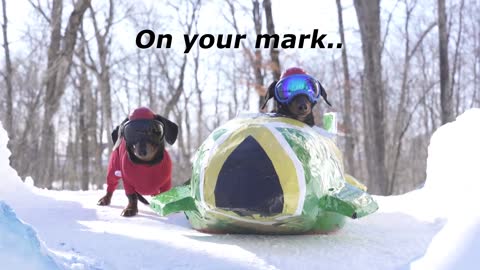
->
<box><xmin>0</xmin><ymin>0</ymin><xmax>480</xmax><ymax>195</ymax></box>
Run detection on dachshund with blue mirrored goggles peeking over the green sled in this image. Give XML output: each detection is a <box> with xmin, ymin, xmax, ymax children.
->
<box><xmin>262</xmin><ymin>67</ymin><xmax>332</xmax><ymax>126</ymax></box>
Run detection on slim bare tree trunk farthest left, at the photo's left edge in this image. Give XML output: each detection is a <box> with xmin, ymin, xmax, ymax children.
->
<box><xmin>2</xmin><ymin>0</ymin><xmax>15</xmax><ymax>137</ymax></box>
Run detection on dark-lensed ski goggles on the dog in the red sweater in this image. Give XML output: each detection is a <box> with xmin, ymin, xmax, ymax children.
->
<box><xmin>122</xmin><ymin>119</ymin><xmax>165</xmax><ymax>145</ymax></box>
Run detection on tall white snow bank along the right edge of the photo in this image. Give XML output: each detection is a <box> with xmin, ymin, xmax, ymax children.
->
<box><xmin>411</xmin><ymin>109</ymin><xmax>480</xmax><ymax>270</ymax></box>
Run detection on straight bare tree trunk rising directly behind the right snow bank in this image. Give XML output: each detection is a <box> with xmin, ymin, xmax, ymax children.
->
<box><xmin>437</xmin><ymin>0</ymin><xmax>454</xmax><ymax>124</ymax></box>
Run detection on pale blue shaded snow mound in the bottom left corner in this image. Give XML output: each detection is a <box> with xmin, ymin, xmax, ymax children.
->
<box><xmin>0</xmin><ymin>201</ymin><xmax>60</xmax><ymax>270</ymax></box>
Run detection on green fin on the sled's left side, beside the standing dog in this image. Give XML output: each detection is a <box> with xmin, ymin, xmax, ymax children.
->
<box><xmin>150</xmin><ymin>185</ymin><xmax>197</xmax><ymax>216</ymax></box>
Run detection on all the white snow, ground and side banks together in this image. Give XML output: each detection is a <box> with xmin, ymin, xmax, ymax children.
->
<box><xmin>0</xmin><ymin>109</ymin><xmax>480</xmax><ymax>270</ymax></box>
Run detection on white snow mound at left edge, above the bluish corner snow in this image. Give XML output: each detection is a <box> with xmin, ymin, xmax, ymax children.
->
<box><xmin>0</xmin><ymin>122</ymin><xmax>30</xmax><ymax>202</ymax></box>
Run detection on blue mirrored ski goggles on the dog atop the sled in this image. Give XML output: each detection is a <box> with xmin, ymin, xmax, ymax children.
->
<box><xmin>275</xmin><ymin>74</ymin><xmax>324</xmax><ymax>104</ymax></box>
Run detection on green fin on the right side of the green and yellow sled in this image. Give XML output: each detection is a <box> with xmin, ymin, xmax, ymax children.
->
<box><xmin>319</xmin><ymin>183</ymin><xmax>378</xmax><ymax>218</ymax></box>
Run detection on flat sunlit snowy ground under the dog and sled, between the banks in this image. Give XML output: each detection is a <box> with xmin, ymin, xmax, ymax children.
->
<box><xmin>4</xmin><ymin>190</ymin><xmax>443</xmax><ymax>269</ymax></box>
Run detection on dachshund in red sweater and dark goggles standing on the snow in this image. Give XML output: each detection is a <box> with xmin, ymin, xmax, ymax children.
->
<box><xmin>98</xmin><ymin>107</ymin><xmax>178</xmax><ymax>217</ymax></box>
